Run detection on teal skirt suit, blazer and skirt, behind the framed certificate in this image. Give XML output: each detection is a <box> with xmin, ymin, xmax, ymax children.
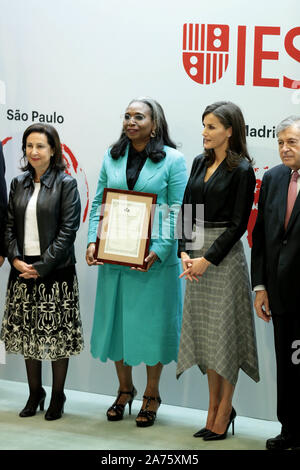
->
<box><xmin>88</xmin><ymin>146</ymin><xmax>187</xmax><ymax>366</ymax></box>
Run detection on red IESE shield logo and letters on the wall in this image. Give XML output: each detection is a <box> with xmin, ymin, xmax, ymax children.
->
<box><xmin>183</xmin><ymin>23</ymin><xmax>300</xmax><ymax>89</ymax></box>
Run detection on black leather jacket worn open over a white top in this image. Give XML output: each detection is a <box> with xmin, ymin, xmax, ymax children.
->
<box><xmin>5</xmin><ymin>168</ymin><xmax>81</xmax><ymax>277</ymax></box>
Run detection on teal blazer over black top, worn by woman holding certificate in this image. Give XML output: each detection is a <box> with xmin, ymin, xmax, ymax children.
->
<box><xmin>88</xmin><ymin>146</ymin><xmax>187</xmax><ymax>269</ymax></box>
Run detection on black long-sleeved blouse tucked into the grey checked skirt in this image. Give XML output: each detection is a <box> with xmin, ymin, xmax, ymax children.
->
<box><xmin>178</xmin><ymin>155</ymin><xmax>256</xmax><ymax>265</ymax></box>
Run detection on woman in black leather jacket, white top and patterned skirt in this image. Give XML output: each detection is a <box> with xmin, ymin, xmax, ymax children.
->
<box><xmin>1</xmin><ymin>124</ymin><xmax>83</xmax><ymax>420</ymax></box>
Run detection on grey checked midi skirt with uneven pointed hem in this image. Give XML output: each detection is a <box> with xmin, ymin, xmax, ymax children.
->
<box><xmin>176</xmin><ymin>228</ymin><xmax>259</xmax><ymax>385</ymax></box>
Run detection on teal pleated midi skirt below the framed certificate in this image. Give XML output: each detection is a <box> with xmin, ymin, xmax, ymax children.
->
<box><xmin>91</xmin><ymin>262</ymin><xmax>182</xmax><ymax>366</ymax></box>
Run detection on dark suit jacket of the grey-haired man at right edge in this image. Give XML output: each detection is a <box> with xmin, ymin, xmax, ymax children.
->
<box><xmin>251</xmin><ymin>165</ymin><xmax>300</xmax><ymax>315</ymax></box>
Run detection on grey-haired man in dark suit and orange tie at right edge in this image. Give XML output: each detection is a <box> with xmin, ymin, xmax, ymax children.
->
<box><xmin>251</xmin><ymin>116</ymin><xmax>300</xmax><ymax>449</ymax></box>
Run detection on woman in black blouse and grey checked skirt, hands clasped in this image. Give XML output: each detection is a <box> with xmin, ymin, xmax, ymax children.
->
<box><xmin>177</xmin><ymin>101</ymin><xmax>259</xmax><ymax>441</ymax></box>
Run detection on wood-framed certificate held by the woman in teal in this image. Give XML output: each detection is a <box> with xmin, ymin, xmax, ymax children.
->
<box><xmin>94</xmin><ymin>188</ymin><xmax>157</xmax><ymax>269</ymax></box>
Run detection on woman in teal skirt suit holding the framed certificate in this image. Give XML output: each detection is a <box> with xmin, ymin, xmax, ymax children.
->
<box><xmin>86</xmin><ymin>98</ymin><xmax>187</xmax><ymax>427</ymax></box>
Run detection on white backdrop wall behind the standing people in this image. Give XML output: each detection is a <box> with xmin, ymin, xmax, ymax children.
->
<box><xmin>0</xmin><ymin>0</ymin><xmax>300</xmax><ymax>419</ymax></box>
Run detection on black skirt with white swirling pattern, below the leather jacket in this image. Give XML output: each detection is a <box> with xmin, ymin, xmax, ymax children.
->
<box><xmin>0</xmin><ymin>257</ymin><xmax>83</xmax><ymax>361</ymax></box>
